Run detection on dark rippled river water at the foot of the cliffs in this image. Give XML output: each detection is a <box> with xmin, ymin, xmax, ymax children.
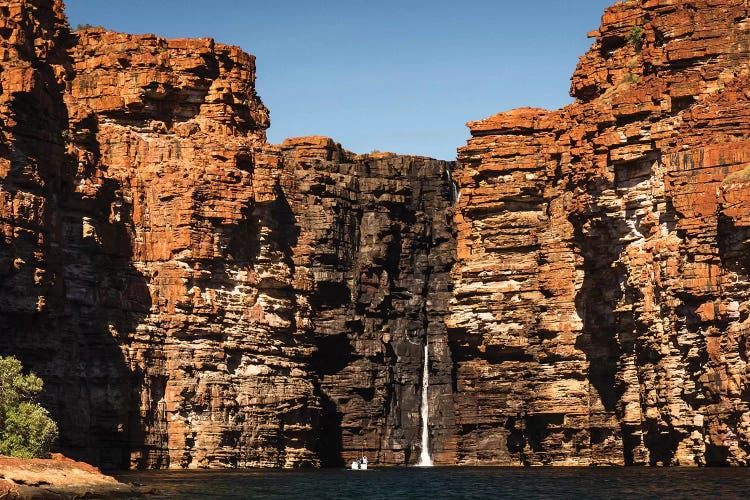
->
<box><xmin>115</xmin><ymin>467</ymin><xmax>750</xmax><ymax>500</ymax></box>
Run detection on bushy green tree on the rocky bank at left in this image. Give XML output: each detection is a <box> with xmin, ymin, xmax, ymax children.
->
<box><xmin>0</xmin><ymin>357</ymin><xmax>58</xmax><ymax>458</ymax></box>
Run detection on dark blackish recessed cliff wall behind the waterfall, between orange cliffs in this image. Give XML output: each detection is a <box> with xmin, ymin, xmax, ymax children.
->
<box><xmin>280</xmin><ymin>137</ymin><xmax>455</xmax><ymax>465</ymax></box>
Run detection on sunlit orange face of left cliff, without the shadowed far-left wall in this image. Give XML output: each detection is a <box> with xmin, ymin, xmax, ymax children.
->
<box><xmin>59</xmin><ymin>30</ymin><xmax>320</xmax><ymax>467</ymax></box>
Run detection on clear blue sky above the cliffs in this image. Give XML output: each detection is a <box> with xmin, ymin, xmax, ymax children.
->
<box><xmin>66</xmin><ymin>0</ymin><xmax>614</xmax><ymax>159</ymax></box>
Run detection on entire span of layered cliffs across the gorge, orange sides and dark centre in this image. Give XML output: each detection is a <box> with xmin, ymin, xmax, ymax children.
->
<box><xmin>0</xmin><ymin>0</ymin><xmax>750</xmax><ymax>468</ymax></box>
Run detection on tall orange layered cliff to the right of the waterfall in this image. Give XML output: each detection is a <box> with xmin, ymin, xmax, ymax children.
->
<box><xmin>448</xmin><ymin>0</ymin><xmax>750</xmax><ymax>465</ymax></box>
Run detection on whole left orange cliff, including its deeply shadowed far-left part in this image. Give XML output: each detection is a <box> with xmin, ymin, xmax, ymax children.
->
<box><xmin>0</xmin><ymin>1</ymin><xmax>320</xmax><ymax>467</ymax></box>
